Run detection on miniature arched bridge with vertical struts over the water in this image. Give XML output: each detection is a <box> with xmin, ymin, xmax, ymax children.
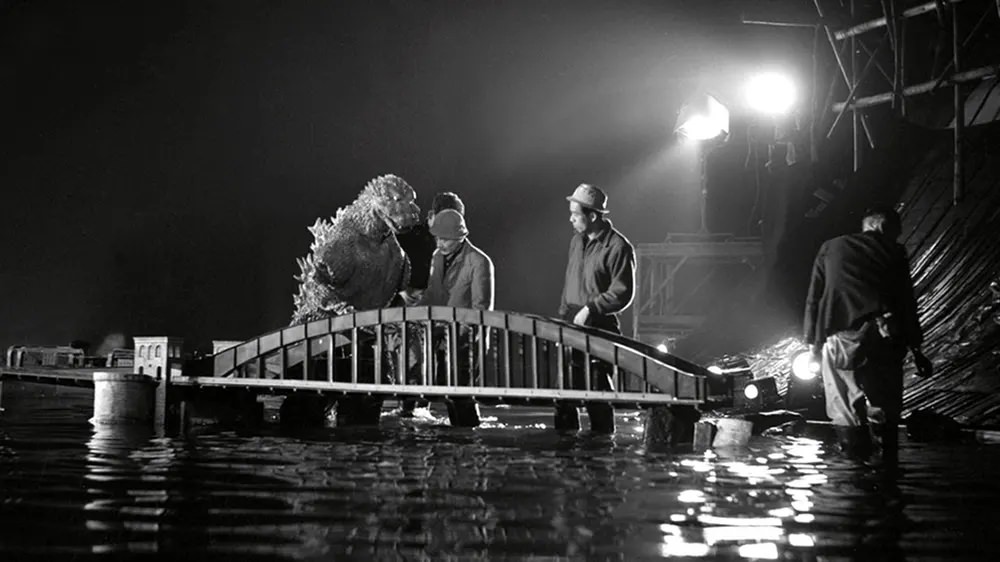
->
<box><xmin>191</xmin><ymin>306</ymin><xmax>709</xmax><ymax>406</ymax></box>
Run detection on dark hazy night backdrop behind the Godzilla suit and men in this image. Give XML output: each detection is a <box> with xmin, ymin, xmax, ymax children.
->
<box><xmin>0</xmin><ymin>0</ymin><xmax>811</xmax><ymax>347</ymax></box>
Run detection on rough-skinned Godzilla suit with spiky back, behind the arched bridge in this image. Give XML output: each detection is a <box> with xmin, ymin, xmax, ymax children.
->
<box><xmin>291</xmin><ymin>174</ymin><xmax>420</xmax><ymax>324</ymax></box>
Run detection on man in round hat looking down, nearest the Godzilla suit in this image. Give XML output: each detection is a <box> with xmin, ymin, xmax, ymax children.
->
<box><xmin>419</xmin><ymin>209</ymin><xmax>493</xmax><ymax>427</ymax></box>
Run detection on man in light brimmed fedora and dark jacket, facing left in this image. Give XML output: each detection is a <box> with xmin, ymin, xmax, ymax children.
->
<box><xmin>556</xmin><ymin>183</ymin><xmax>635</xmax><ymax>432</ymax></box>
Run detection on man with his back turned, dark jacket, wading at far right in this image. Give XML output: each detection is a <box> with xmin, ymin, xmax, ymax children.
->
<box><xmin>804</xmin><ymin>209</ymin><xmax>931</xmax><ymax>461</ymax></box>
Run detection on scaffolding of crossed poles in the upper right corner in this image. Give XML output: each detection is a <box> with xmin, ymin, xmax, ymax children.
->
<box><xmin>743</xmin><ymin>0</ymin><xmax>1000</xmax><ymax>204</ymax></box>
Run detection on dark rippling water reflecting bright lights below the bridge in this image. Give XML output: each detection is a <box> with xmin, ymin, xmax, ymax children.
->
<box><xmin>0</xmin><ymin>383</ymin><xmax>1000</xmax><ymax>560</ymax></box>
